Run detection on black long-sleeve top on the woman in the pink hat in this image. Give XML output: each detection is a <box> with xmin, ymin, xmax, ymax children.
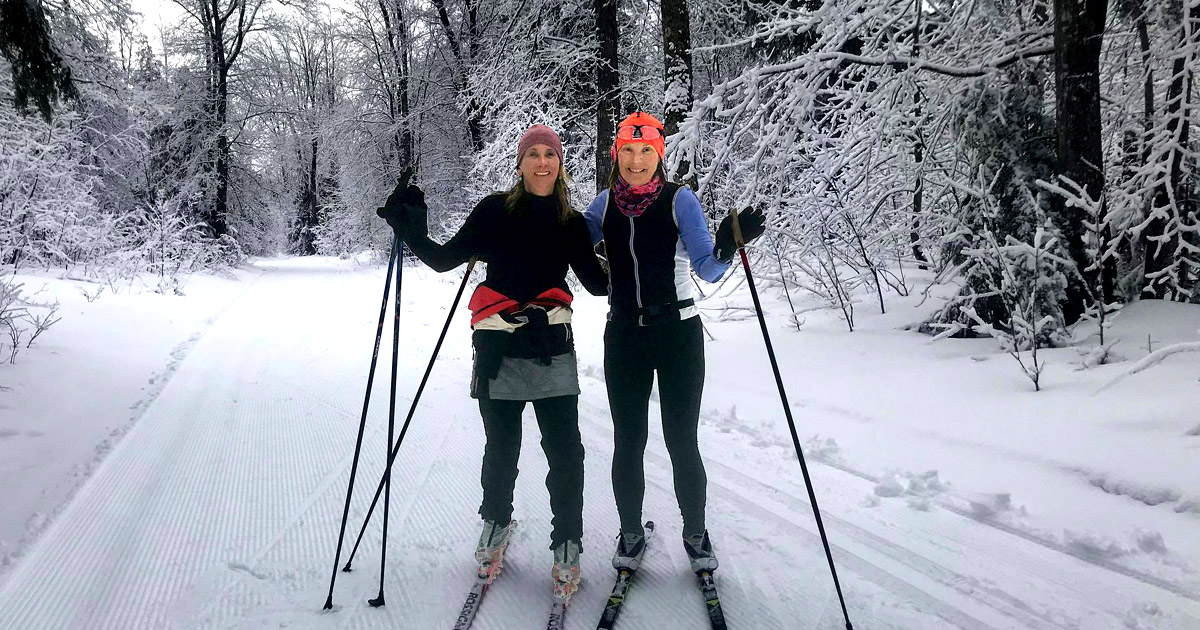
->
<box><xmin>406</xmin><ymin>193</ymin><xmax>608</xmax><ymax>302</ymax></box>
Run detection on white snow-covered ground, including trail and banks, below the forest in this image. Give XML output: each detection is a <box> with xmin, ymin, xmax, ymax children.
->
<box><xmin>0</xmin><ymin>253</ymin><xmax>1200</xmax><ymax>630</ymax></box>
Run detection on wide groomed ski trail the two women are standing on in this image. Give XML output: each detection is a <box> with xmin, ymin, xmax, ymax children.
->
<box><xmin>0</xmin><ymin>259</ymin><xmax>1200</xmax><ymax>630</ymax></box>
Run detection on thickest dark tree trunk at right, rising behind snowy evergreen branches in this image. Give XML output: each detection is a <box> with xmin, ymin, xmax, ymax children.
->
<box><xmin>1054</xmin><ymin>0</ymin><xmax>1109</xmax><ymax>324</ymax></box>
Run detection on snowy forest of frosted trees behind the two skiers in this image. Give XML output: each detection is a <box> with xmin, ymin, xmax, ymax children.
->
<box><xmin>0</xmin><ymin>0</ymin><xmax>1200</xmax><ymax>352</ymax></box>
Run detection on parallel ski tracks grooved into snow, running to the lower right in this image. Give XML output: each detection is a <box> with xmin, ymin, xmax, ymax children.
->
<box><xmin>581</xmin><ymin>401</ymin><xmax>1200</xmax><ymax>629</ymax></box>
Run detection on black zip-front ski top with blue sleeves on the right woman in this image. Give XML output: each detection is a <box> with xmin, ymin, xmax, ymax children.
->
<box><xmin>584</xmin><ymin>182</ymin><xmax>730</xmax><ymax>325</ymax></box>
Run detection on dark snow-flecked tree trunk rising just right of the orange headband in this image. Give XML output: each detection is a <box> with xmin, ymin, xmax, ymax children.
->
<box><xmin>660</xmin><ymin>0</ymin><xmax>696</xmax><ymax>188</ymax></box>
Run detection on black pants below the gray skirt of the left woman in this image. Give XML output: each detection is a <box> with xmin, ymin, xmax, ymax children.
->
<box><xmin>479</xmin><ymin>396</ymin><xmax>583</xmax><ymax>548</ymax></box>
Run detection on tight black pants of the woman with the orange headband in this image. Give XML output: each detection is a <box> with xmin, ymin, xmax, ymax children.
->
<box><xmin>604</xmin><ymin>317</ymin><xmax>708</xmax><ymax>535</ymax></box>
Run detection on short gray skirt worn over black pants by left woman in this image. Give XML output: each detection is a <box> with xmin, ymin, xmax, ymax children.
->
<box><xmin>470</xmin><ymin>350</ymin><xmax>580</xmax><ymax>401</ymax></box>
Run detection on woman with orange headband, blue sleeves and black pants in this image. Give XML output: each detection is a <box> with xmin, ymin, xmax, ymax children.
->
<box><xmin>584</xmin><ymin>112</ymin><xmax>766</xmax><ymax>572</ymax></box>
